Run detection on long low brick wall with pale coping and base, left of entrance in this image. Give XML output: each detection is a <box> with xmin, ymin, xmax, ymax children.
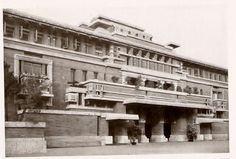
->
<box><xmin>18</xmin><ymin>109</ymin><xmax>112</xmax><ymax>148</ymax></box>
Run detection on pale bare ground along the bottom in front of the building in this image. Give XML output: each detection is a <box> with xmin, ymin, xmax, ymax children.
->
<box><xmin>9</xmin><ymin>141</ymin><xmax>229</xmax><ymax>156</ymax></box>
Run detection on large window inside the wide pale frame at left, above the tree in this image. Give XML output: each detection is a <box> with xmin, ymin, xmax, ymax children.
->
<box><xmin>20</xmin><ymin>61</ymin><xmax>47</xmax><ymax>76</ymax></box>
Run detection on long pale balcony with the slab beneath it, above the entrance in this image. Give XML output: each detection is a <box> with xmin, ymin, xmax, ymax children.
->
<box><xmin>82</xmin><ymin>80</ymin><xmax>211</xmax><ymax>109</ymax></box>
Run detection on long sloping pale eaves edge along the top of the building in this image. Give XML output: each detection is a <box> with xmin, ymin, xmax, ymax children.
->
<box><xmin>3</xmin><ymin>9</ymin><xmax>228</xmax><ymax>71</ymax></box>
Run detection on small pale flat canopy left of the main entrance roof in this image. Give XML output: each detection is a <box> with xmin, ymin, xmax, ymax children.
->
<box><xmin>103</xmin><ymin>113</ymin><xmax>139</xmax><ymax>120</ymax></box>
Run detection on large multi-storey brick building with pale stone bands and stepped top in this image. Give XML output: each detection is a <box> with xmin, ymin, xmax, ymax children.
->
<box><xmin>3</xmin><ymin>10</ymin><xmax>228</xmax><ymax>147</ymax></box>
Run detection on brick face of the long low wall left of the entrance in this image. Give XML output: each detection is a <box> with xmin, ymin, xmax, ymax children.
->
<box><xmin>21</xmin><ymin>113</ymin><xmax>99</xmax><ymax>136</ymax></box>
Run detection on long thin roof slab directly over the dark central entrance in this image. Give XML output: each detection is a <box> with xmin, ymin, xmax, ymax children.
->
<box><xmin>124</xmin><ymin>98</ymin><xmax>212</xmax><ymax>109</ymax></box>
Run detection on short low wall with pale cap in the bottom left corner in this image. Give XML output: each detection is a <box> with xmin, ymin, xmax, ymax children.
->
<box><xmin>5</xmin><ymin>122</ymin><xmax>47</xmax><ymax>156</ymax></box>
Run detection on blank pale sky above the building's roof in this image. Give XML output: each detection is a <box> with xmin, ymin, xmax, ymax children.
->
<box><xmin>3</xmin><ymin>0</ymin><xmax>227</xmax><ymax>67</ymax></box>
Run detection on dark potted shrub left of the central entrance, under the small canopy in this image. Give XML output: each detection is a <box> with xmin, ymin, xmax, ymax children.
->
<box><xmin>128</xmin><ymin>122</ymin><xmax>141</xmax><ymax>145</ymax></box>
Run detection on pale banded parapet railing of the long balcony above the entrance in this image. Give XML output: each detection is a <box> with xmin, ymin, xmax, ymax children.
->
<box><xmin>84</xmin><ymin>80</ymin><xmax>211</xmax><ymax>105</ymax></box>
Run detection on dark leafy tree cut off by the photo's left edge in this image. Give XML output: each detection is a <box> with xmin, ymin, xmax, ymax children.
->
<box><xmin>4</xmin><ymin>62</ymin><xmax>22</xmax><ymax>121</ymax></box>
